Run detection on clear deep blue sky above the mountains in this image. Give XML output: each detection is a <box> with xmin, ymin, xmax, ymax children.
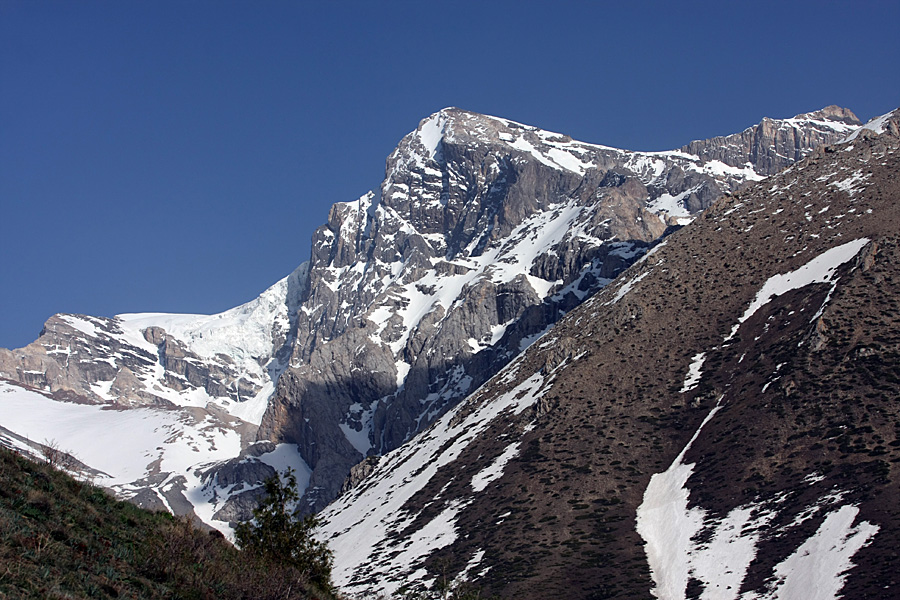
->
<box><xmin>0</xmin><ymin>0</ymin><xmax>900</xmax><ymax>348</ymax></box>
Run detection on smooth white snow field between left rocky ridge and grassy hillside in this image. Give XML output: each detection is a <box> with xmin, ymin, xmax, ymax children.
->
<box><xmin>0</xmin><ymin>382</ymin><xmax>311</xmax><ymax>535</ymax></box>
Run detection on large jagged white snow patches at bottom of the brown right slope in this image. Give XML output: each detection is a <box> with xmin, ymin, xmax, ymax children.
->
<box><xmin>636</xmin><ymin>400</ymin><xmax>879</xmax><ymax>600</ymax></box>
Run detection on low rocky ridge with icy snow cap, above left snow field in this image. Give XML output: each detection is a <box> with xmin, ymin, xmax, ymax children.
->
<box><xmin>0</xmin><ymin>264</ymin><xmax>306</xmax><ymax>414</ymax></box>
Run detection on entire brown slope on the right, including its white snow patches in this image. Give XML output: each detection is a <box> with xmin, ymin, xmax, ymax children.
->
<box><xmin>322</xmin><ymin>110</ymin><xmax>900</xmax><ymax>600</ymax></box>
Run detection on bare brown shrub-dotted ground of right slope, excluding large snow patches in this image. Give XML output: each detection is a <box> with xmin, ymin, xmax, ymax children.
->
<box><xmin>324</xmin><ymin>113</ymin><xmax>900</xmax><ymax>598</ymax></box>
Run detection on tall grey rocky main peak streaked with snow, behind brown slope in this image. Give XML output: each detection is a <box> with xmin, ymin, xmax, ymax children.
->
<box><xmin>260</xmin><ymin>109</ymin><xmax>858</xmax><ymax>510</ymax></box>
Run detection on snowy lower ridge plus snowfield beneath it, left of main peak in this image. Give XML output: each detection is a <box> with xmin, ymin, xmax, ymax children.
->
<box><xmin>0</xmin><ymin>264</ymin><xmax>310</xmax><ymax>531</ymax></box>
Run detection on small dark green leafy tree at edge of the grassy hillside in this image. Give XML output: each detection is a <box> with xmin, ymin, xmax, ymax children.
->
<box><xmin>234</xmin><ymin>468</ymin><xmax>333</xmax><ymax>592</ymax></box>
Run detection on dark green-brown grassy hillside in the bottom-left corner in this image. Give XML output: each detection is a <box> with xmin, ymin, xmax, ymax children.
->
<box><xmin>0</xmin><ymin>446</ymin><xmax>330</xmax><ymax>600</ymax></box>
